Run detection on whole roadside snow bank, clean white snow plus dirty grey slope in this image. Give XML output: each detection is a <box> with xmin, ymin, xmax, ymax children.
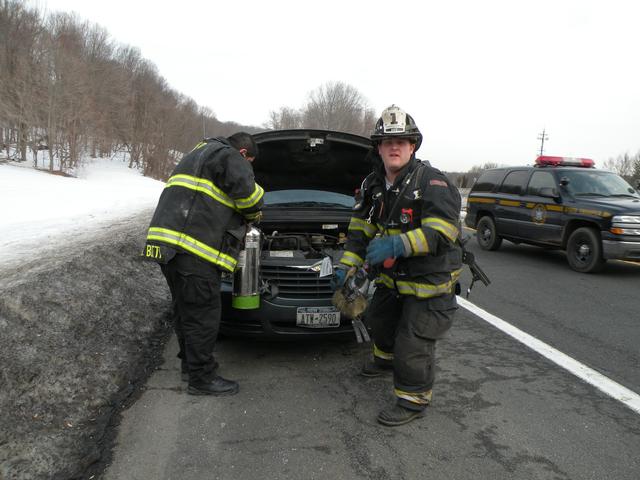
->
<box><xmin>0</xmin><ymin>157</ymin><xmax>170</xmax><ymax>479</ymax></box>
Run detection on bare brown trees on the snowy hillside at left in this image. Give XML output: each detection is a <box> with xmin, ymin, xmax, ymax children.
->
<box><xmin>0</xmin><ymin>0</ymin><xmax>258</xmax><ymax>179</ymax></box>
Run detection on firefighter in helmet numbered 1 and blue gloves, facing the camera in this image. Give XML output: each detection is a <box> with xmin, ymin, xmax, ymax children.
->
<box><xmin>335</xmin><ymin>105</ymin><xmax>462</xmax><ymax>426</ymax></box>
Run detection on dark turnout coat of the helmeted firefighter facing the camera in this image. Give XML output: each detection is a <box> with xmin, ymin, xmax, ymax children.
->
<box><xmin>340</xmin><ymin>156</ymin><xmax>462</xmax><ymax>309</ymax></box>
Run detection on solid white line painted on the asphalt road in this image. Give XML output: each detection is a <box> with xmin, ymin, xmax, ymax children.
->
<box><xmin>458</xmin><ymin>297</ymin><xmax>640</xmax><ymax>413</ymax></box>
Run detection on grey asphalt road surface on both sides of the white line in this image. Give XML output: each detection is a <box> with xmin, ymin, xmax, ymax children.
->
<box><xmin>104</xmin><ymin>231</ymin><xmax>640</xmax><ymax>480</ymax></box>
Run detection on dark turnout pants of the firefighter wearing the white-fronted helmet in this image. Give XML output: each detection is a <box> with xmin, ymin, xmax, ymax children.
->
<box><xmin>367</xmin><ymin>286</ymin><xmax>455</xmax><ymax>410</ymax></box>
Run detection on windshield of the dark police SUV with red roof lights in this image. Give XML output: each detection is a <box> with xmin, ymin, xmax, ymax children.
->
<box><xmin>562</xmin><ymin>170</ymin><xmax>640</xmax><ymax>198</ymax></box>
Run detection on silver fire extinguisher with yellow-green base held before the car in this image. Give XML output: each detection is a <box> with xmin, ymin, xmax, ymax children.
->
<box><xmin>231</xmin><ymin>225</ymin><xmax>262</xmax><ymax>310</ymax></box>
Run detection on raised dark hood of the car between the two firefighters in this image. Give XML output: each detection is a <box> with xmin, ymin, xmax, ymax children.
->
<box><xmin>253</xmin><ymin>129</ymin><xmax>372</xmax><ymax>195</ymax></box>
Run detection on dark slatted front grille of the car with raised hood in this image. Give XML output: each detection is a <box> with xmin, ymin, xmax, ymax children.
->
<box><xmin>260</xmin><ymin>265</ymin><xmax>333</xmax><ymax>298</ymax></box>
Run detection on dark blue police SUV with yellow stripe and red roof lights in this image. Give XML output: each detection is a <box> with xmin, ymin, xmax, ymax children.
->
<box><xmin>465</xmin><ymin>156</ymin><xmax>640</xmax><ymax>273</ymax></box>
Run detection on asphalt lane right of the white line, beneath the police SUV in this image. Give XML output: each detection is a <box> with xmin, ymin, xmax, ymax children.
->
<box><xmin>465</xmin><ymin>230</ymin><xmax>640</xmax><ymax>394</ymax></box>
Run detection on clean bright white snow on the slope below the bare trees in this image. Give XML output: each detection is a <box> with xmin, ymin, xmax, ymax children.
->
<box><xmin>0</xmin><ymin>158</ymin><xmax>164</xmax><ymax>266</ymax></box>
